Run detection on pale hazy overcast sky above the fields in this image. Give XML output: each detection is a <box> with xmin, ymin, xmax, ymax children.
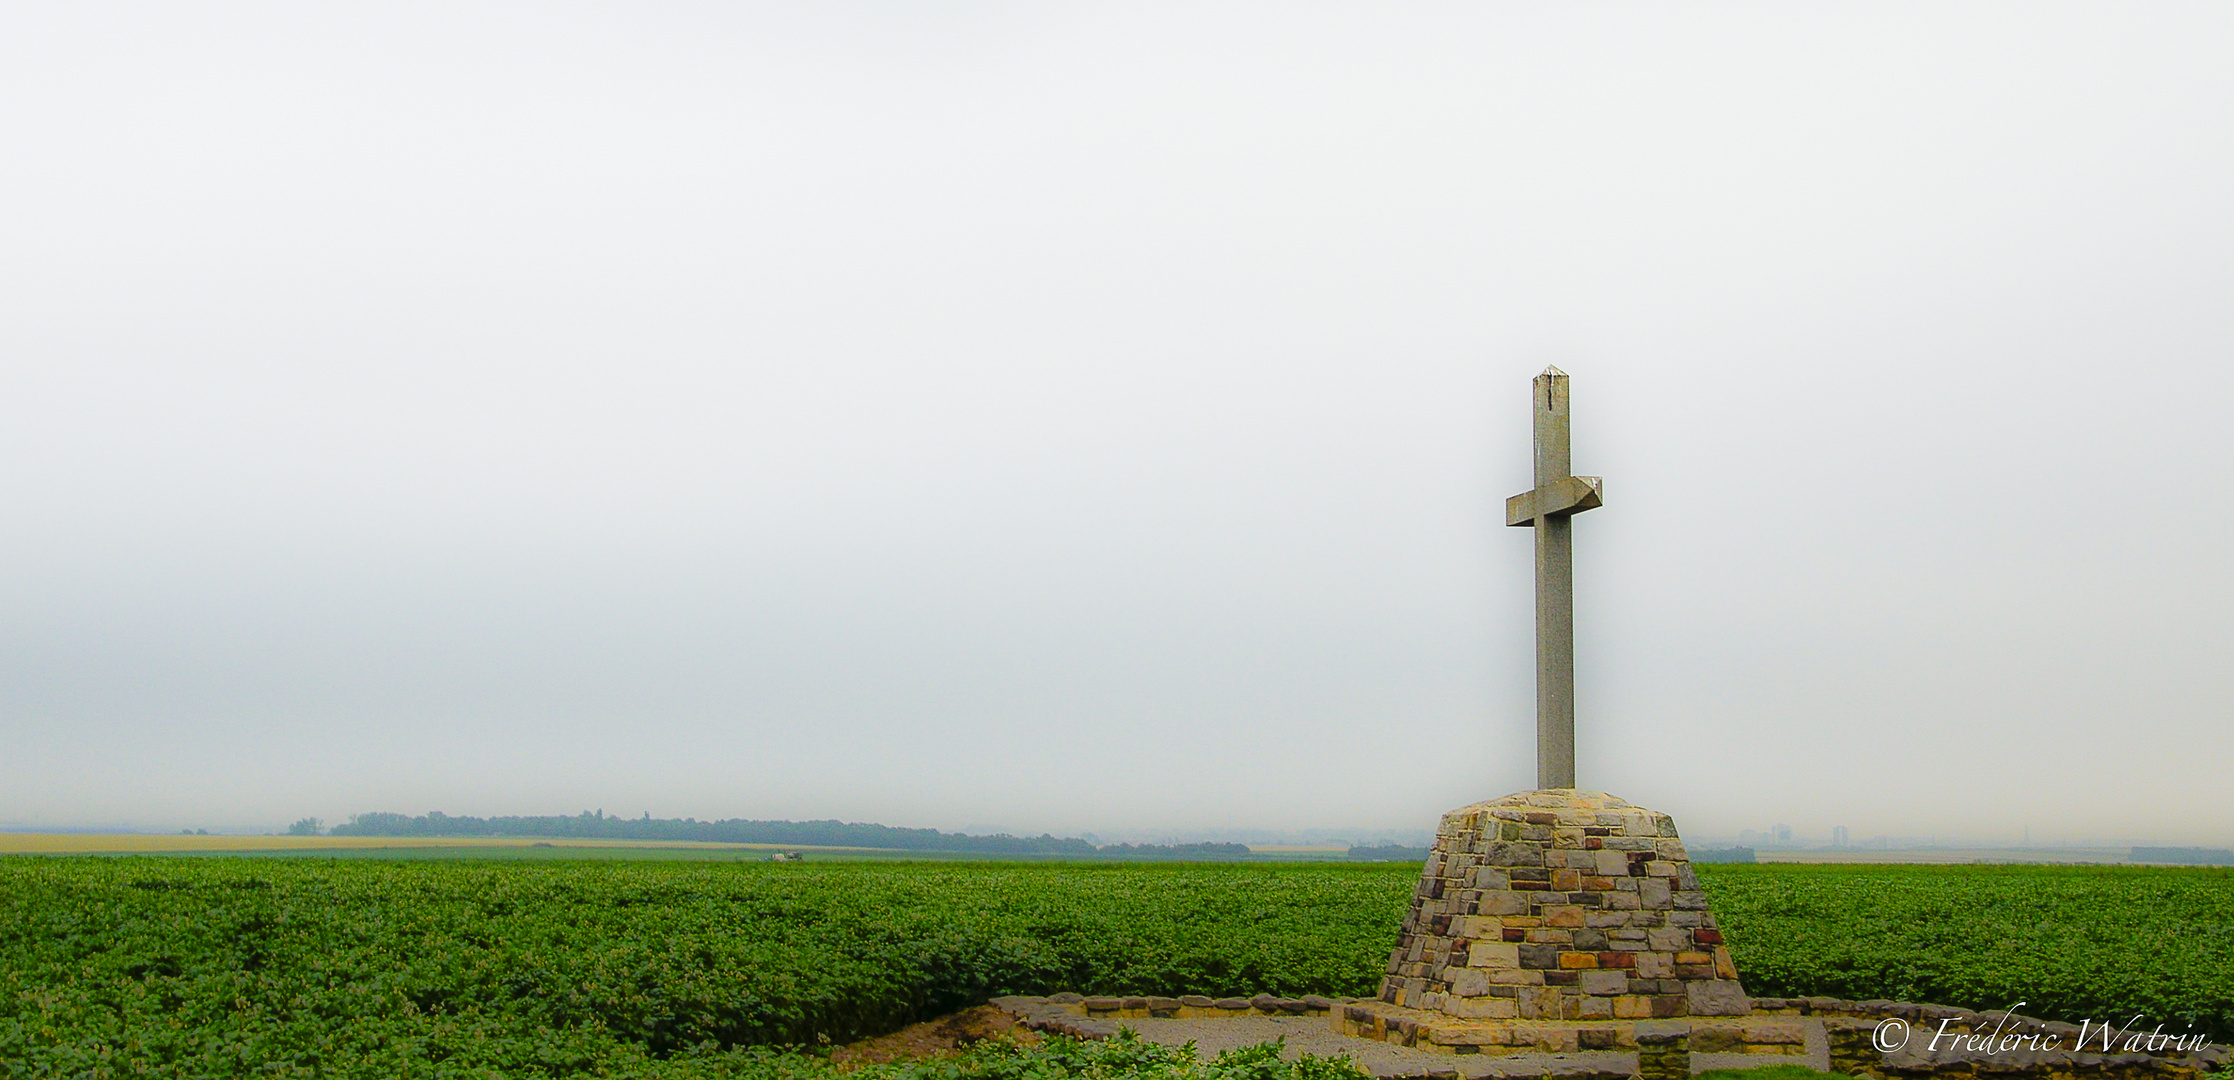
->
<box><xmin>0</xmin><ymin>2</ymin><xmax>2234</xmax><ymax>845</ymax></box>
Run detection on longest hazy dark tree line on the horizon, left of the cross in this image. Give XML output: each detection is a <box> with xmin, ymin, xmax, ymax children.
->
<box><xmin>331</xmin><ymin>809</ymin><xmax>1249</xmax><ymax>859</ymax></box>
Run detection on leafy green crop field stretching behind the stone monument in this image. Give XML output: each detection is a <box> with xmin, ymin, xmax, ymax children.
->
<box><xmin>0</xmin><ymin>856</ymin><xmax>2234</xmax><ymax>1078</ymax></box>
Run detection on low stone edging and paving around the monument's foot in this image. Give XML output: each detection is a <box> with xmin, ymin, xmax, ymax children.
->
<box><xmin>992</xmin><ymin>993</ymin><xmax>2230</xmax><ymax>1080</ymax></box>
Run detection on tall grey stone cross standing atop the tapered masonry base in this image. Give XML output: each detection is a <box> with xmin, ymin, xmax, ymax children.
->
<box><xmin>1506</xmin><ymin>367</ymin><xmax>1602</xmax><ymax>787</ymax></box>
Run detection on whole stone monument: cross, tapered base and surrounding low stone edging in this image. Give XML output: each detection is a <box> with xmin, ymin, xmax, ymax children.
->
<box><xmin>994</xmin><ymin>369</ymin><xmax>2227</xmax><ymax>1080</ymax></box>
